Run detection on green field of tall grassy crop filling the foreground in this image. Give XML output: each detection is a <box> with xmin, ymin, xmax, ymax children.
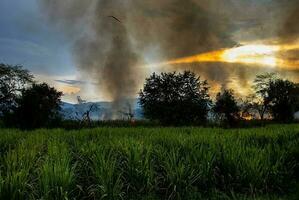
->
<box><xmin>0</xmin><ymin>125</ymin><xmax>299</xmax><ymax>199</ymax></box>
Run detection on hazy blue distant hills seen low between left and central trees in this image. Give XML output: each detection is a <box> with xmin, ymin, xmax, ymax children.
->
<box><xmin>60</xmin><ymin>100</ymin><xmax>143</xmax><ymax>120</ymax></box>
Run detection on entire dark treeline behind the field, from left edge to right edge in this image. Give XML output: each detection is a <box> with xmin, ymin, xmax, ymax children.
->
<box><xmin>0</xmin><ymin>64</ymin><xmax>299</xmax><ymax>129</ymax></box>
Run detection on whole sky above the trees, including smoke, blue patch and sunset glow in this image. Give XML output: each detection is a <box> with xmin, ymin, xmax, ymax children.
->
<box><xmin>0</xmin><ymin>0</ymin><xmax>299</xmax><ymax>104</ymax></box>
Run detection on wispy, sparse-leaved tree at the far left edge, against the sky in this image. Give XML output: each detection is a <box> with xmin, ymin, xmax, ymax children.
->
<box><xmin>0</xmin><ymin>64</ymin><xmax>33</xmax><ymax>114</ymax></box>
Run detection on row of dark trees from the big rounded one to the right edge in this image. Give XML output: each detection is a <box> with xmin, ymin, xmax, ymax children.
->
<box><xmin>139</xmin><ymin>71</ymin><xmax>299</xmax><ymax>127</ymax></box>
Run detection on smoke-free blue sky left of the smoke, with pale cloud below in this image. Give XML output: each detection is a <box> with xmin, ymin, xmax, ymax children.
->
<box><xmin>0</xmin><ymin>0</ymin><xmax>88</xmax><ymax>102</ymax></box>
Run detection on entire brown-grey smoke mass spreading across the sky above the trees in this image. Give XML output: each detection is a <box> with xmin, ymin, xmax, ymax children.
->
<box><xmin>40</xmin><ymin>0</ymin><xmax>299</xmax><ymax>108</ymax></box>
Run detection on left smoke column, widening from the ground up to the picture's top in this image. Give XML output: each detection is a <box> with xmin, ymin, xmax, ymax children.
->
<box><xmin>41</xmin><ymin>0</ymin><xmax>141</xmax><ymax>117</ymax></box>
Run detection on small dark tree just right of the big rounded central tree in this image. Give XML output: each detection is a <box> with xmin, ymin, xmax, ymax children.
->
<box><xmin>213</xmin><ymin>90</ymin><xmax>240</xmax><ymax>126</ymax></box>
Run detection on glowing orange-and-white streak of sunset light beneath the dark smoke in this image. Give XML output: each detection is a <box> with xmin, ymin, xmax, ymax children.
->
<box><xmin>154</xmin><ymin>44</ymin><xmax>299</xmax><ymax>70</ymax></box>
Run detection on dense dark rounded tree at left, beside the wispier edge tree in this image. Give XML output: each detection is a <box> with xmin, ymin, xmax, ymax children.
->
<box><xmin>7</xmin><ymin>83</ymin><xmax>62</xmax><ymax>129</ymax></box>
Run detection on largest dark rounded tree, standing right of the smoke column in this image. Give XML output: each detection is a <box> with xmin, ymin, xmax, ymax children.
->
<box><xmin>139</xmin><ymin>71</ymin><xmax>210</xmax><ymax>125</ymax></box>
